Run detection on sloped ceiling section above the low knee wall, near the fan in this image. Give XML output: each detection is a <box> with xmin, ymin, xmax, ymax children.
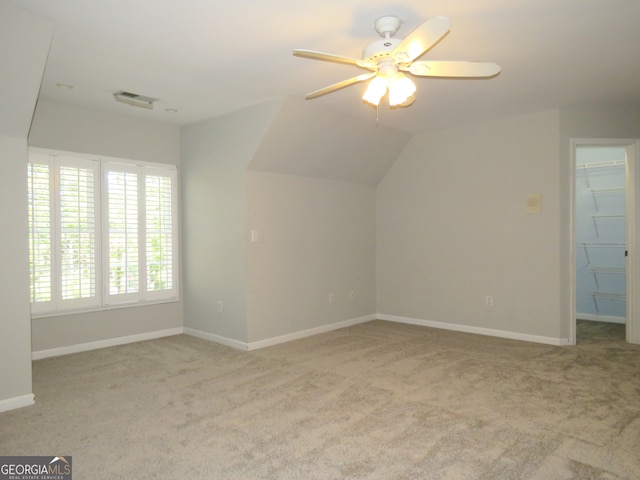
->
<box><xmin>248</xmin><ymin>97</ymin><xmax>411</xmax><ymax>186</ymax></box>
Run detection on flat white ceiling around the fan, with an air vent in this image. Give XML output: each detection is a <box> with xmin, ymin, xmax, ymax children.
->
<box><xmin>8</xmin><ymin>0</ymin><xmax>640</xmax><ymax>133</ymax></box>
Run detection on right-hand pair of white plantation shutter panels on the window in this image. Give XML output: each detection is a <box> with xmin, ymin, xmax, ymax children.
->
<box><xmin>104</xmin><ymin>162</ymin><xmax>177</xmax><ymax>304</ymax></box>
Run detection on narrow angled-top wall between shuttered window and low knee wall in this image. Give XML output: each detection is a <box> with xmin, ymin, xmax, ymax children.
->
<box><xmin>181</xmin><ymin>101</ymin><xmax>280</xmax><ymax>342</ymax></box>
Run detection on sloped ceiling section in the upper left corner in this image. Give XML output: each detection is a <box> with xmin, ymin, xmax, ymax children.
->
<box><xmin>0</xmin><ymin>3</ymin><xmax>53</xmax><ymax>138</ymax></box>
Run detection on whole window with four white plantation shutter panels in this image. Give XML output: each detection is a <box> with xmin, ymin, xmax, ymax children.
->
<box><xmin>27</xmin><ymin>150</ymin><xmax>178</xmax><ymax>315</ymax></box>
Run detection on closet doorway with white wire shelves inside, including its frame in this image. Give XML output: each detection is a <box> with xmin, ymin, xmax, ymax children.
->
<box><xmin>570</xmin><ymin>139</ymin><xmax>640</xmax><ymax>344</ymax></box>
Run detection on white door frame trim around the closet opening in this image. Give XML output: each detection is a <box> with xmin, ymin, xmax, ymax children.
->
<box><xmin>569</xmin><ymin>138</ymin><xmax>640</xmax><ymax>345</ymax></box>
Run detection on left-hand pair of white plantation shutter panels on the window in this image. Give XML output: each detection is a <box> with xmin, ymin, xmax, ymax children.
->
<box><xmin>27</xmin><ymin>153</ymin><xmax>100</xmax><ymax>314</ymax></box>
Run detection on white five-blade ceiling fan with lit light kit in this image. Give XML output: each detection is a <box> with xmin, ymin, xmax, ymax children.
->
<box><xmin>293</xmin><ymin>15</ymin><xmax>500</xmax><ymax>107</ymax></box>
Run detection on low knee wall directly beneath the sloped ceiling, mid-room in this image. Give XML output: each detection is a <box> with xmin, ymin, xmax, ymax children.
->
<box><xmin>246</xmin><ymin>171</ymin><xmax>376</xmax><ymax>342</ymax></box>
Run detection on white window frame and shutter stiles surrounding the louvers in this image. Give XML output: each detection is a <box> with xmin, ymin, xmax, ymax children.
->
<box><xmin>28</xmin><ymin>147</ymin><xmax>180</xmax><ymax>318</ymax></box>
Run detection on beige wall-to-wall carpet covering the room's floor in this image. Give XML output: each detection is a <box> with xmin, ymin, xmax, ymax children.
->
<box><xmin>0</xmin><ymin>321</ymin><xmax>640</xmax><ymax>480</ymax></box>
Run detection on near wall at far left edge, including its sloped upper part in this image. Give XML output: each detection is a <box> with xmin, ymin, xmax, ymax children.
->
<box><xmin>0</xmin><ymin>2</ymin><xmax>53</xmax><ymax>411</ymax></box>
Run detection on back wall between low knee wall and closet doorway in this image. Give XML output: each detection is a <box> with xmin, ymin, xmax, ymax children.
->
<box><xmin>377</xmin><ymin>111</ymin><xmax>565</xmax><ymax>340</ymax></box>
